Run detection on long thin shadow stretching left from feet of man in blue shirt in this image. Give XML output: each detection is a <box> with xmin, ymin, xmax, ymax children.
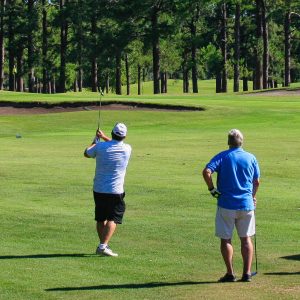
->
<box><xmin>45</xmin><ymin>281</ymin><xmax>217</xmax><ymax>292</ymax></box>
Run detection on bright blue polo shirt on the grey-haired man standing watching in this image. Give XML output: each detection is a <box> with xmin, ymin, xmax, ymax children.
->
<box><xmin>206</xmin><ymin>148</ymin><xmax>260</xmax><ymax>210</ymax></box>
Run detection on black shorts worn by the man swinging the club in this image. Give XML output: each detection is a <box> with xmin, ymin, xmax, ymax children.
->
<box><xmin>94</xmin><ymin>191</ymin><xmax>126</xmax><ymax>224</ymax></box>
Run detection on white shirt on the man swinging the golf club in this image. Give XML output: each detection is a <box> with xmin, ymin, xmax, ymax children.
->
<box><xmin>86</xmin><ymin>140</ymin><xmax>131</xmax><ymax>194</ymax></box>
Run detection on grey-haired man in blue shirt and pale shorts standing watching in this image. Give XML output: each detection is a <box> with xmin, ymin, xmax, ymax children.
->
<box><xmin>202</xmin><ymin>129</ymin><xmax>260</xmax><ymax>282</ymax></box>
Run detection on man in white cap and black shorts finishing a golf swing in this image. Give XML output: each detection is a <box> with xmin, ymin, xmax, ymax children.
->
<box><xmin>84</xmin><ymin>123</ymin><xmax>131</xmax><ymax>256</ymax></box>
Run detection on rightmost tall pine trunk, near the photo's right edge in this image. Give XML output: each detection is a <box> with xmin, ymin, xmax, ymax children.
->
<box><xmin>284</xmin><ymin>7</ymin><xmax>291</xmax><ymax>86</ymax></box>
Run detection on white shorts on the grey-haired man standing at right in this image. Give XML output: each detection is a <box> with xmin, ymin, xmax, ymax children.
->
<box><xmin>216</xmin><ymin>207</ymin><xmax>255</xmax><ymax>240</ymax></box>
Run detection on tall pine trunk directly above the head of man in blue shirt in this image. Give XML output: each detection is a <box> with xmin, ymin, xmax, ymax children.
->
<box><xmin>233</xmin><ymin>2</ymin><xmax>241</xmax><ymax>92</ymax></box>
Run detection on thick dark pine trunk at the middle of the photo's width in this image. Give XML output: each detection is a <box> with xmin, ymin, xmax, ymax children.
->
<box><xmin>151</xmin><ymin>5</ymin><xmax>160</xmax><ymax>94</ymax></box>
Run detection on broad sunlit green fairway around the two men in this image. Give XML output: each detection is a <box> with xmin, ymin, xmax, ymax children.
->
<box><xmin>0</xmin><ymin>89</ymin><xmax>300</xmax><ymax>300</ymax></box>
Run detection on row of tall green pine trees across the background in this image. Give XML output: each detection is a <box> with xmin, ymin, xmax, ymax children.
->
<box><xmin>0</xmin><ymin>0</ymin><xmax>300</xmax><ymax>94</ymax></box>
